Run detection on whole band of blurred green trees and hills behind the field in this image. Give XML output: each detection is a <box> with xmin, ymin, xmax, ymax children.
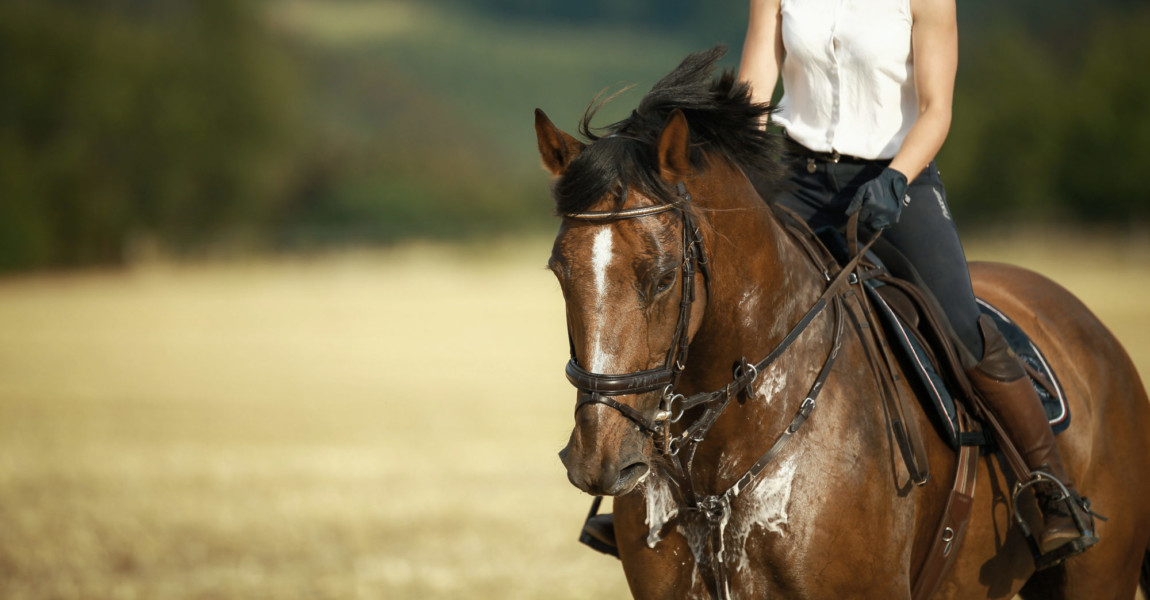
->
<box><xmin>0</xmin><ymin>0</ymin><xmax>1150</xmax><ymax>271</ymax></box>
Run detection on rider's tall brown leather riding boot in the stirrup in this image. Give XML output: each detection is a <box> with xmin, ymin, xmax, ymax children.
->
<box><xmin>967</xmin><ymin>315</ymin><xmax>1098</xmax><ymax>568</ymax></box>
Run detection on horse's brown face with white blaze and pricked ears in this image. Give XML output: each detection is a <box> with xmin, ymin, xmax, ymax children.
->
<box><xmin>536</xmin><ymin>107</ymin><xmax>706</xmax><ymax>495</ymax></box>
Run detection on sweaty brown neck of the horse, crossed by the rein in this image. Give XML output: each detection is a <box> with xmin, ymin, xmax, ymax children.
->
<box><xmin>690</xmin><ymin>164</ymin><xmax>833</xmax><ymax>490</ymax></box>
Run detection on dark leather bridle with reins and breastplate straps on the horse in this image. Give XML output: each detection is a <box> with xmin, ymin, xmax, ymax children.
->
<box><xmin>564</xmin><ymin>182</ymin><xmax>877</xmax><ymax>599</ymax></box>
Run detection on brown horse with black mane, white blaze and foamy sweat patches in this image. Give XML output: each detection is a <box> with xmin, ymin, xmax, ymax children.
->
<box><xmin>536</xmin><ymin>51</ymin><xmax>1150</xmax><ymax>600</ymax></box>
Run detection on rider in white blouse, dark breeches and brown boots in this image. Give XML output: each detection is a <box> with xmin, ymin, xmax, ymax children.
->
<box><xmin>739</xmin><ymin>0</ymin><xmax>1097</xmax><ymax>556</ymax></box>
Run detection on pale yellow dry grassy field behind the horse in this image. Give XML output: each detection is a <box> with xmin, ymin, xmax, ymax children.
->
<box><xmin>0</xmin><ymin>236</ymin><xmax>1150</xmax><ymax>600</ymax></box>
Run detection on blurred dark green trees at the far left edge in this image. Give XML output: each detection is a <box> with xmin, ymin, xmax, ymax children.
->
<box><xmin>0</xmin><ymin>0</ymin><xmax>298</xmax><ymax>269</ymax></box>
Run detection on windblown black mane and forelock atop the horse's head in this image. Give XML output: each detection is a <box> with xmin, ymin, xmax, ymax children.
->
<box><xmin>553</xmin><ymin>46</ymin><xmax>783</xmax><ymax>214</ymax></box>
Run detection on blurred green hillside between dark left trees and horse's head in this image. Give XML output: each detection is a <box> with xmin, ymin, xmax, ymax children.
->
<box><xmin>261</xmin><ymin>1</ymin><xmax>708</xmax><ymax>244</ymax></box>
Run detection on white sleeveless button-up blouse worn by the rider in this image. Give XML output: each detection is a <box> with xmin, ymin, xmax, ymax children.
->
<box><xmin>773</xmin><ymin>0</ymin><xmax>918</xmax><ymax>159</ymax></box>
